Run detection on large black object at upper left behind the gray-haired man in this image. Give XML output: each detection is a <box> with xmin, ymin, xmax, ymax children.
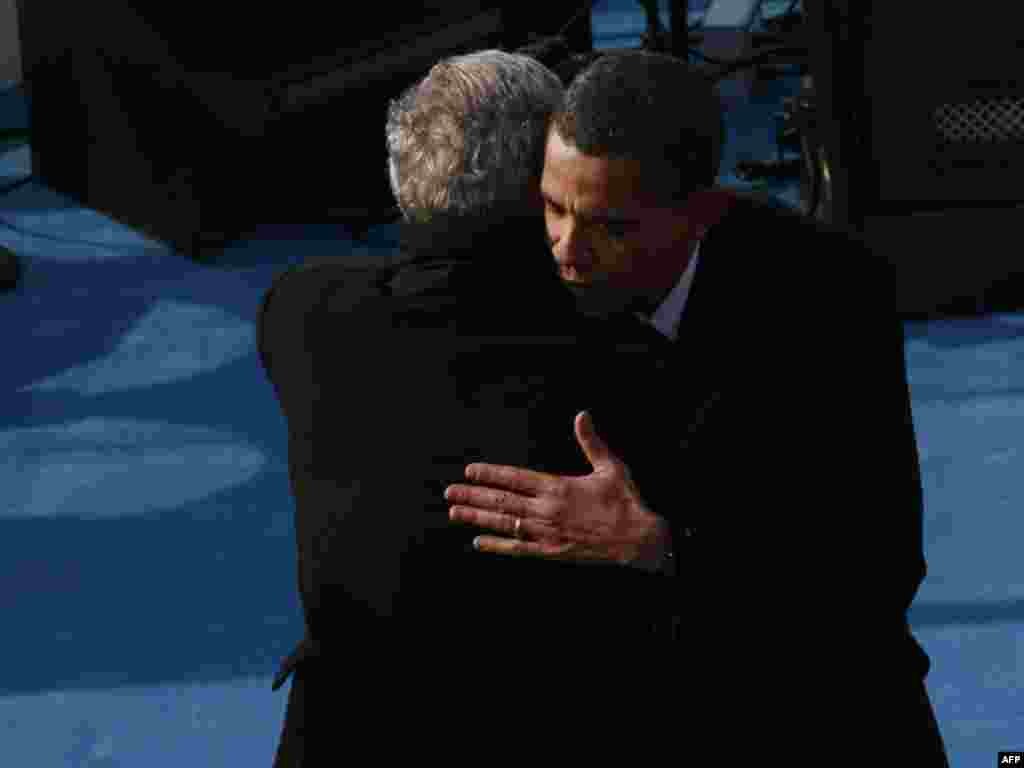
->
<box><xmin>18</xmin><ymin>0</ymin><xmax>592</xmax><ymax>260</ymax></box>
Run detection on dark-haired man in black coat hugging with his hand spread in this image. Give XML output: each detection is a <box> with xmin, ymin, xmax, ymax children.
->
<box><xmin>445</xmin><ymin>53</ymin><xmax>946</xmax><ymax>766</ymax></box>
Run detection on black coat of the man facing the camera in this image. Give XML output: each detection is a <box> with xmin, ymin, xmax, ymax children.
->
<box><xmin>670</xmin><ymin>198</ymin><xmax>941</xmax><ymax>765</ymax></box>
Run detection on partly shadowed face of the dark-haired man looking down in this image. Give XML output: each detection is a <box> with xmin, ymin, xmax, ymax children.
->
<box><xmin>541</xmin><ymin>129</ymin><xmax>697</xmax><ymax>309</ymax></box>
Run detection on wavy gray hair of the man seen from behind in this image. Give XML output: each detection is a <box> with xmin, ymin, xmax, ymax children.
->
<box><xmin>386</xmin><ymin>49</ymin><xmax>563</xmax><ymax>218</ymax></box>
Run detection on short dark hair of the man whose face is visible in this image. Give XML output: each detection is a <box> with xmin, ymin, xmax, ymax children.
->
<box><xmin>552</xmin><ymin>51</ymin><xmax>725</xmax><ymax>205</ymax></box>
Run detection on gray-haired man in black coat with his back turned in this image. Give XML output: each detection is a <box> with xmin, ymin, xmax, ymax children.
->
<box><xmin>258</xmin><ymin>50</ymin><xmax>680</xmax><ymax>768</ymax></box>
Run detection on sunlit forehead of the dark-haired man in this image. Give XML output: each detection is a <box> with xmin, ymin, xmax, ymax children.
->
<box><xmin>541</xmin><ymin>129</ymin><xmax>646</xmax><ymax>211</ymax></box>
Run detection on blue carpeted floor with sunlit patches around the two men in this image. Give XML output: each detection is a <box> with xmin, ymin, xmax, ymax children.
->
<box><xmin>0</xmin><ymin>1</ymin><xmax>1011</xmax><ymax>768</ymax></box>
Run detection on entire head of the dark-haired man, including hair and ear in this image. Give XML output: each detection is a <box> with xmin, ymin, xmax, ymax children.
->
<box><xmin>542</xmin><ymin>49</ymin><xmax>730</xmax><ymax>314</ymax></box>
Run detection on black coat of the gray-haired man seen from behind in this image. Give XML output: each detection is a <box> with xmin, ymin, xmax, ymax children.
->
<box><xmin>259</xmin><ymin>211</ymin><xmax>696</xmax><ymax>766</ymax></box>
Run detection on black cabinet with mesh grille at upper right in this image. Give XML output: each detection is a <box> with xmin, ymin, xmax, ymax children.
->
<box><xmin>804</xmin><ymin>0</ymin><xmax>1024</xmax><ymax>318</ymax></box>
